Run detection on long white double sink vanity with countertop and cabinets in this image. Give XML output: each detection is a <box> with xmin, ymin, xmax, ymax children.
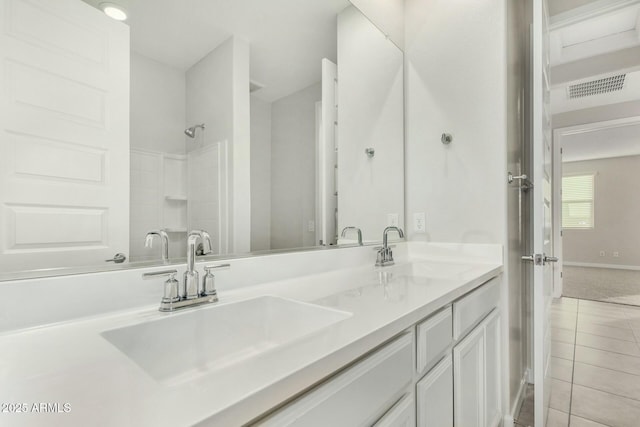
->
<box><xmin>0</xmin><ymin>242</ymin><xmax>502</xmax><ymax>427</ymax></box>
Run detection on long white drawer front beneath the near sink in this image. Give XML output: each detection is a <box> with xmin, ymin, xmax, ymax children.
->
<box><xmin>256</xmin><ymin>333</ymin><xmax>413</xmax><ymax>427</ymax></box>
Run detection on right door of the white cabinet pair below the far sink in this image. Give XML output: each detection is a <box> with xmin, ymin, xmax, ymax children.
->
<box><xmin>482</xmin><ymin>310</ymin><xmax>502</xmax><ymax>427</ymax></box>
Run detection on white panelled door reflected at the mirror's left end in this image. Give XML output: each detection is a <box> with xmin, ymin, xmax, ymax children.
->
<box><xmin>0</xmin><ymin>0</ymin><xmax>129</xmax><ymax>272</ymax></box>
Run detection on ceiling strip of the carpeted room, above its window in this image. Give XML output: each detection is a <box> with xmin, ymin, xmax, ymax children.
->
<box><xmin>562</xmin><ymin>123</ymin><xmax>640</xmax><ymax>162</ymax></box>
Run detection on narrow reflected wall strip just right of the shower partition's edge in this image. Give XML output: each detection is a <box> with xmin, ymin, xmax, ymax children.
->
<box><xmin>251</xmin><ymin>96</ymin><xmax>271</xmax><ymax>251</ymax></box>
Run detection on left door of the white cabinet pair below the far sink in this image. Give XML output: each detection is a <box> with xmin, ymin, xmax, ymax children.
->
<box><xmin>453</xmin><ymin>324</ymin><xmax>485</xmax><ymax>427</ymax></box>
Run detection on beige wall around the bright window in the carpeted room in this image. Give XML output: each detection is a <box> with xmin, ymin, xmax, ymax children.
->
<box><xmin>562</xmin><ymin>156</ymin><xmax>640</xmax><ymax>267</ymax></box>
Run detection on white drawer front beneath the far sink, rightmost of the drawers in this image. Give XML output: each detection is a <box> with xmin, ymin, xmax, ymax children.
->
<box><xmin>453</xmin><ymin>277</ymin><xmax>500</xmax><ymax>340</ymax></box>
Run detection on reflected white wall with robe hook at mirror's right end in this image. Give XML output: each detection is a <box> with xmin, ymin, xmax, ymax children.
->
<box><xmin>337</xmin><ymin>7</ymin><xmax>404</xmax><ymax>244</ymax></box>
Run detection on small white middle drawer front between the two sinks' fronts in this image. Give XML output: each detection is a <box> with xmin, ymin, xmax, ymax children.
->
<box><xmin>416</xmin><ymin>306</ymin><xmax>453</xmax><ymax>373</ymax></box>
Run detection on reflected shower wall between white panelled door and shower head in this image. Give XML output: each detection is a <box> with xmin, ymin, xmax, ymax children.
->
<box><xmin>129</xmin><ymin>52</ymin><xmax>186</xmax><ymax>261</ymax></box>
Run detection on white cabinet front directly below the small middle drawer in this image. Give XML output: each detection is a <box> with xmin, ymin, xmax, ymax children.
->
<box><xmin>416</xmin><ymin>356</ymin><xmax>453</xmax><ymax>427</ymax></box>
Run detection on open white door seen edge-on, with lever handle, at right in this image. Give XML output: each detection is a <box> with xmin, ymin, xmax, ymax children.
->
<box><xmin>530</xmin><ymin>0</ymin><xmax>553</xmax><ymax>427</ymax></box>
